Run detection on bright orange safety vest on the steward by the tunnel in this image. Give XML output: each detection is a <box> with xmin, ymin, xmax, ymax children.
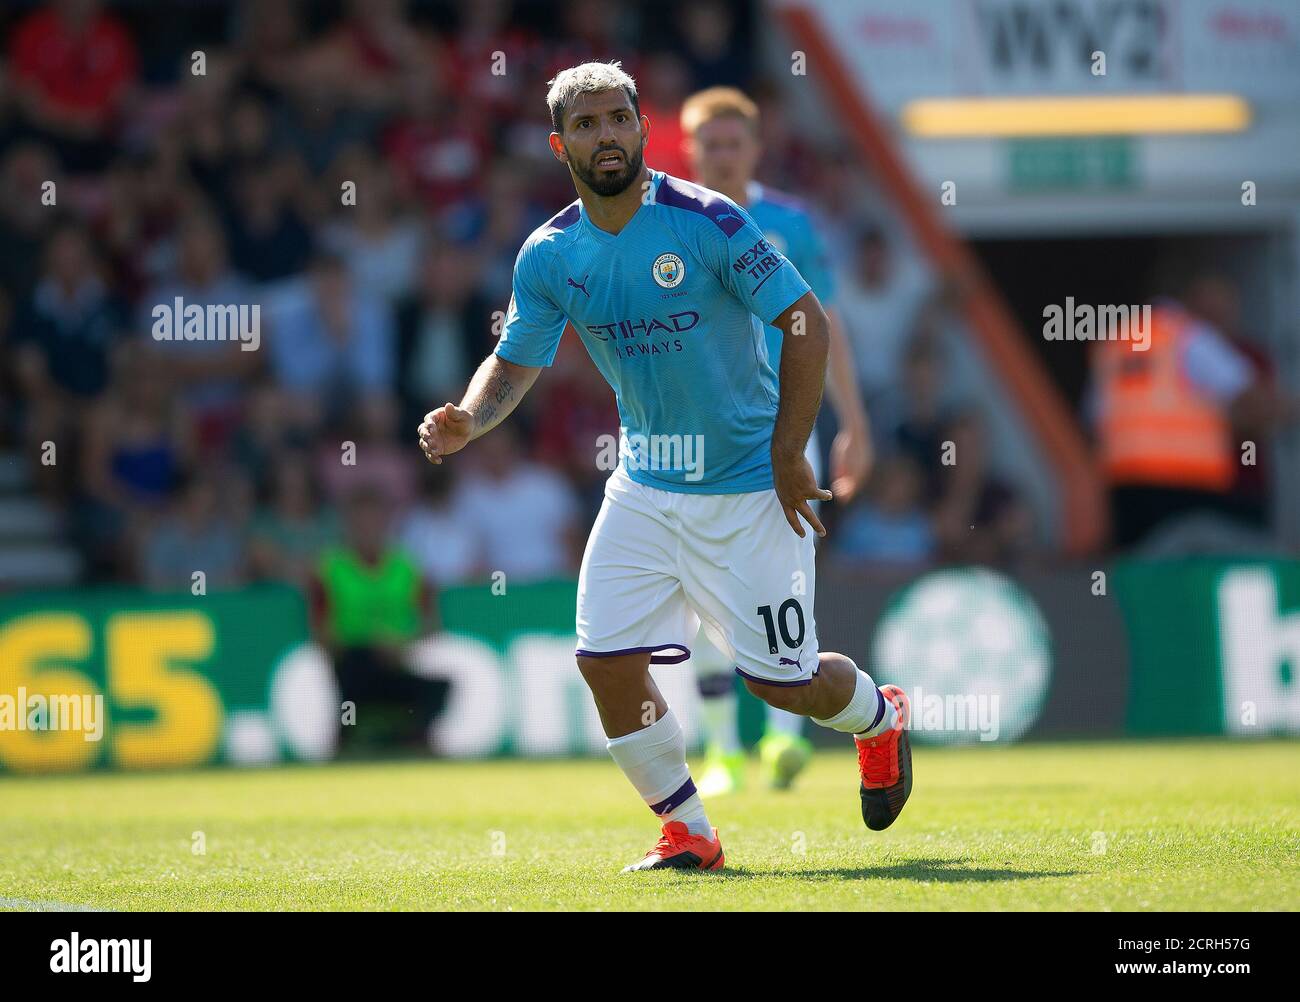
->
<box><xmin>1092</xmin><ymin>307</ymin><xmax>1234</xmax><ymax>491</ymax></box>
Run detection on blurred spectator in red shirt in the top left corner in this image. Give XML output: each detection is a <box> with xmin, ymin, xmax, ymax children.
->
<box><xmin>9</xmin><ymin>0</ymin><xmax>139</xmax><ymax>172</ymax></box>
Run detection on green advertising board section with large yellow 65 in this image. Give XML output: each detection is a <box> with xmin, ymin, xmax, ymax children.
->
<box><xmin>0</xmin><ymin>587</ymin><xmax>307</xmax><ymax>772</ymax></box>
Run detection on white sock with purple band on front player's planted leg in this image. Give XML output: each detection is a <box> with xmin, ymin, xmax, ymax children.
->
<box><xmin>607</xmin><ymin>710</ymin><xmax>714</xmax><ymax>838</ymax></box>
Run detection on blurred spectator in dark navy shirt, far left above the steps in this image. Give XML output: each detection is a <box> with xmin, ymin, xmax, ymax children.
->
<box><xmin>14</xmin><ymin>224</ymin><xmax>126</xmax><ymax>498</ymax></box>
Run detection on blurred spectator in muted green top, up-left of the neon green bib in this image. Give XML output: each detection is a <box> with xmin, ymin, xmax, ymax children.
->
<box><xmin>248</xmin><ymin>452</ymin><xmax>339</xmax><ymax>587</ymax></box>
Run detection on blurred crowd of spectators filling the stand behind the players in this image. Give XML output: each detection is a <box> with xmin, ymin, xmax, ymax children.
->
<box><xmin>0</xmin><ymin>0</ymin><xmax>1045</xmax><ymax>603</ymax></box>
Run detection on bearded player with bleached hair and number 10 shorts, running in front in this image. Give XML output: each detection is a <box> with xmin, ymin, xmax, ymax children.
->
<box><xmin>419</xmin><ymin>62</ymin><xmax>913</xmax><ymax>869</ymax></box>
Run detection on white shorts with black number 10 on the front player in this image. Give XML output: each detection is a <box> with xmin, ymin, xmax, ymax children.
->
<box><xmin>577</xmin><ymin>465</ymin><xmax>818</xmax><ymax>685</ymax></box>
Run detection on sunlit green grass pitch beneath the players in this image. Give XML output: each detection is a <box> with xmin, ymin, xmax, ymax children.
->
<box><xmin>0</xmin><ymin>741</ymin><xmax>1300</xmax><ymax>911</ymax></box>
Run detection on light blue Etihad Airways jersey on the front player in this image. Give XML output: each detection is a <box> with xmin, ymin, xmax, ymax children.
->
<box><xmin>497</xmin><ymin>170</ymin><xmax>809</xmax><ymax>494</ymax></box>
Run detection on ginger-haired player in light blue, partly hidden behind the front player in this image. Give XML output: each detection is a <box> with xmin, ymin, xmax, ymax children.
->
<box><xmin>681</xmin><ymin>87</ymin><xmax>871</xmax><ymax>797</ymax></box>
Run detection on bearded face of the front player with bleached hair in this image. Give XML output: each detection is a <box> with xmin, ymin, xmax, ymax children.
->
<box><xmin>551</xmin><ymin>90</ymin><xmax>649</xmax><ymax>198</ymax></box>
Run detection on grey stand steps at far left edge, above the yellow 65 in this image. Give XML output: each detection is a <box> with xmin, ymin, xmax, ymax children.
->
<box><xmin>0</xmin><ymin>451</ymin><xmax>82</xmax><ymax>593</ymax></box>
